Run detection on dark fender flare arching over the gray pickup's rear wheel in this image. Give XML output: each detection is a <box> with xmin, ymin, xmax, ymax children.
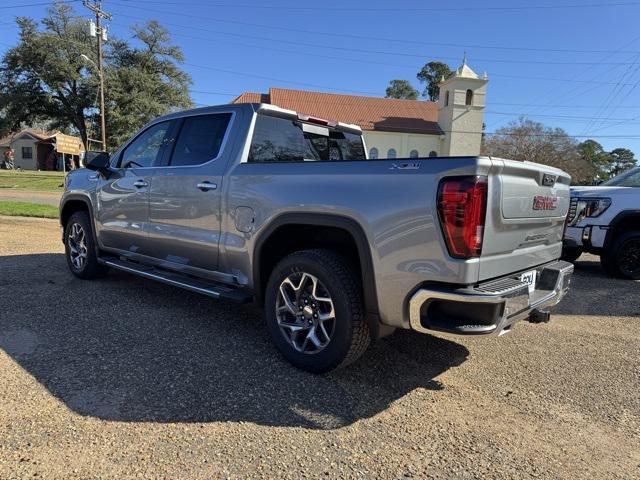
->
<box><xmin>252</xmin><ymin>213</ymin><xmax>378</xmax><ymax>318</ymax></box>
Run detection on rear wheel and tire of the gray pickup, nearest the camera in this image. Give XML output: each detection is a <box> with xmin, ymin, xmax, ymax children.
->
<box><xmin>265</xmin><ymin>250</ymin><xmax>371</xmax><ymax>373</ymax></box>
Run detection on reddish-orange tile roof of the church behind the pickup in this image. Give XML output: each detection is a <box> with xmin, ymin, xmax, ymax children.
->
<box><xmin>233</xmin><ymin>88</ymin><xmax>442</xmax><ymax>135</ymax></box>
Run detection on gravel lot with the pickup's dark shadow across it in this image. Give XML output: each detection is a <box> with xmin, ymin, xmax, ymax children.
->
<box><xmin>0</xmin><ymin>217</ymin><xmax>640</xmax><ymax>480</ymax></box>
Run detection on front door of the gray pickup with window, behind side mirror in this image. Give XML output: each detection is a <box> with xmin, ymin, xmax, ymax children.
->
<box><xmin>96</xmin><ymin>121</ymin><xmax>173</xmax><ymax>255</ymax></box>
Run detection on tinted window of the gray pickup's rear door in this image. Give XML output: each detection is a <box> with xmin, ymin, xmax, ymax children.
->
<box><xmin>170</xmin><ymin>113</ymin><xmax>231</xmax><ymax>167</ymax></box>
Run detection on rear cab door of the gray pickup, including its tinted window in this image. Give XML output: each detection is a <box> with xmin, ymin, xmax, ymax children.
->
<box><xmin>148</xmin><ymin>113</ymin><xmax>232</xmax><ymax>271</ymax></box>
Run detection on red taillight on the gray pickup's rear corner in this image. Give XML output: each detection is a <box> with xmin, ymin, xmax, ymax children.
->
<box><xmin>438</xmin><ymin>176</ymin><xmax>487</xmax><ymax>258</ymax></box>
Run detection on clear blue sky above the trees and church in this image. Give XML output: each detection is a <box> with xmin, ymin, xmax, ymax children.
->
<box><xmin>0</xmin><ymin>0</ymin><xmax>640</xmax><ymax>157</ymax></box>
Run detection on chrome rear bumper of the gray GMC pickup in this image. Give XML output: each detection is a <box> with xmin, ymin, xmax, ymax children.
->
<box><xmin>409</xmin><ymin>261</ymin><xmax>573</xmax><ymax>335</ymax></box>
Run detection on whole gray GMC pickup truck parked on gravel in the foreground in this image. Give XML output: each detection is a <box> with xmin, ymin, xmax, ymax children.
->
<box><xmin>60</xmin><ymin>104</ymin><xmax>573</xmax><ymax>373</ymax></box>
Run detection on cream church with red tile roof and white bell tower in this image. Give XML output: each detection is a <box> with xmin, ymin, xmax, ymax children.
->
<box><xmin>233</xmin><ymin>56</ymin><xmax>488</xmax><ymax>158</ymax></box>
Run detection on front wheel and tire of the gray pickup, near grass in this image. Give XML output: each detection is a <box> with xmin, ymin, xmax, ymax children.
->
<box><xmin>64</xmin><ymin>211</ymin><xmax>109</xmax><ymax>280</ymax></box>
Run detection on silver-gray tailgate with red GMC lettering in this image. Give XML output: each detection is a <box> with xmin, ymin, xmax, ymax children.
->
<box><xmin>479</xmin><ymin>158</ymin><xmax>571</xmax><ymax>280</ymax></box>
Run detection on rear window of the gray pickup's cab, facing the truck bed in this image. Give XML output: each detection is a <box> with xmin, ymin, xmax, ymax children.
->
<box><xmin>249</xmin><ymin>115</ymin><xmax>365</xmax><ymax>162</ymax></box>
